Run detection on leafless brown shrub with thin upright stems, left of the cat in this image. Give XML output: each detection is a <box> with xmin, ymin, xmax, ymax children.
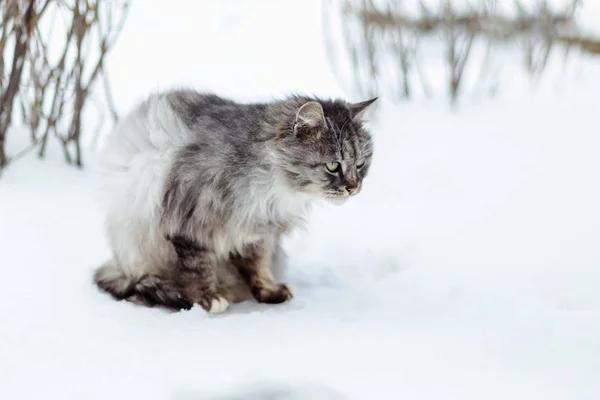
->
<box><xmin>0</xmin><ymin>0</ymin><xmax>130</xmax><ymax>172</ymax></box>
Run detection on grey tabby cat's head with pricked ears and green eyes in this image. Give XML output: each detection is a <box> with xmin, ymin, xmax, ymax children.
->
<box><xmin>276</xmin><ymin>98</ymin><xmax>377</xmax><ymax>202</ymax></box>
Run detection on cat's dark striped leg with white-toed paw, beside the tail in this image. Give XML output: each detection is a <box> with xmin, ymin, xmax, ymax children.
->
<box><xmin>170</xmin><ymin>236</ymin><xmax>229</xmax><ymax>314</ymax></box>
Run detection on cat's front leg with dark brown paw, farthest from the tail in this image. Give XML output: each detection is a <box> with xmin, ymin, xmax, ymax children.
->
<box><xmin>231</xmin><ymin>243</ymin><xmax>293</xmax><ymax>304</ymax></box>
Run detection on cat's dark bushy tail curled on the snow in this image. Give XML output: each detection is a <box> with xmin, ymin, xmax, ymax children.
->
<box><xmin>94</xmin><ymin>261</ymin><xmax>192</xmax><ymax>310</ymax></box>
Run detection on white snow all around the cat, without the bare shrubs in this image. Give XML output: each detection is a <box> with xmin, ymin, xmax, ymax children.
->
<box><xmin>0</xmin><ymin>0</ymin><xmax>600</xmax><ymax>400</ymax></box>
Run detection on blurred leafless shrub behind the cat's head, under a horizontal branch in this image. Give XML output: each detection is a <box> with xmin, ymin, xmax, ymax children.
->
<box><xmin>324</xmin><ymin>0</ymin><xmax>600</xmax><ymax>103</ymax></box>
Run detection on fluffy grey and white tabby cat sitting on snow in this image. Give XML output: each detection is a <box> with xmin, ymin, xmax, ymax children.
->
<box><xmin>94</xmin><ymin>89</ymin><xmax>377</xmax><ymax>313</ymax></box>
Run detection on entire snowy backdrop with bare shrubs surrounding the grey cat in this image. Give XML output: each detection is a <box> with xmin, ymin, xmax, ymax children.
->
<box><xmin>0</xmin><ymin>0</ymin><xmax>600</xmax><ymax>400</ymax></box>
